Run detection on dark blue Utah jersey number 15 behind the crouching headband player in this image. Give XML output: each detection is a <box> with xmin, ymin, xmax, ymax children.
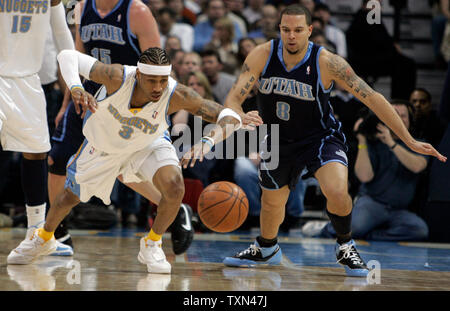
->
<box><xmin>79</xmin><ymin>0</ymin><xmax>141</xmax><ymax>94</ymax></box>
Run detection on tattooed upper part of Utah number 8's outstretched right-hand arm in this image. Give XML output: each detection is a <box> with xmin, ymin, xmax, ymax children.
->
<box><xmin>327</xmin><ymin>55</ymin><xmax>374</xmax><ymax>98</ymax></box>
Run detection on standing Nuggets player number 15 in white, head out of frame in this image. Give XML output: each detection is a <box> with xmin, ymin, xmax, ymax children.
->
<box><xmin>0</xmin><ymin>0</ymin><xmax>74</xmax><ymax>252</ymax></box>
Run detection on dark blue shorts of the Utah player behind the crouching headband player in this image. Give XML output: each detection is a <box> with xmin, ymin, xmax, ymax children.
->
<box><xmin>48</xmin><ymin>101</ymin><xmax>84</xmax><ymax>176</ymax></box>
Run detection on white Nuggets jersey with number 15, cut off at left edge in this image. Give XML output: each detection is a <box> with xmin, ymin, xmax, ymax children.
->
<box><xmin>0</xmin><ymin>0</ymin><xmax>51</xmax><ymax>77</ymax></box>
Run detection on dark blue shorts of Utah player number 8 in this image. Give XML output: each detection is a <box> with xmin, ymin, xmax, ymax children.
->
<box><xmin>259</xmin><ymin>132</ymin><xmax>348</xmax><ymax>190</ymax></box>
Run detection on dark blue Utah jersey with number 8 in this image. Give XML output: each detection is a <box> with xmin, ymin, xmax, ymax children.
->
<box><xmin>257</xmin><ymin>39</ymin><xmax>345</xmax><ymax>145</ymax></box>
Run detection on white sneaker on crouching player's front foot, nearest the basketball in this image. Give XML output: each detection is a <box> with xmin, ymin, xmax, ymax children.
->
<box><xmin>138</xmin><ymin>238</ymin><xmax>172</xmax><ymax>273</ymax></box>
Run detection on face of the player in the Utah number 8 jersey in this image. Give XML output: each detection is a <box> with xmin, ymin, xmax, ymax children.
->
<box><xmin>280</xmin><ymin>14</ymin><xmax>312</xmax><ymax>54</ymax></box>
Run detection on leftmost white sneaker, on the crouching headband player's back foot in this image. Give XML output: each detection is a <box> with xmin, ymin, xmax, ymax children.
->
<box><xmin>6</xmin><ymin>231</ymin><xmax>56</xmax><ymax>265</ymax></box>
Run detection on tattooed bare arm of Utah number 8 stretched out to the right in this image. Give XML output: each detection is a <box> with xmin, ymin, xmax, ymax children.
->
<box><xmin>319</xmin><ymin>50</ymin><xmax>446</xmax><ymax>162</ymax></box>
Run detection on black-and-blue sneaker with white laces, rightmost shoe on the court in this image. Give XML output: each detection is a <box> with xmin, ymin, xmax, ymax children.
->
<box><xmin>335</xmin><ymin>240</ymin><xmax>370</xmax><ymax>277</ymax></box>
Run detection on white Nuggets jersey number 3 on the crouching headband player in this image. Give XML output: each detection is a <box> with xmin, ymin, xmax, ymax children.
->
<box><xmin>83</xmin><ymin>66</ymin><xmax>177</xmax><ymax>153</ymax></box>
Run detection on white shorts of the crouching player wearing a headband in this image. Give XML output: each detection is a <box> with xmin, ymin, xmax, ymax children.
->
<box><xmin>65</xmin><ymin>137</ymin><xmax>181</xmax><ymax>205</ymax></box>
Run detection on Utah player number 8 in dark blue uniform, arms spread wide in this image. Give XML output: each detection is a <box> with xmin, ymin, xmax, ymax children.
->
<box><xmin>224</xmin><ymin>5</ymin><xmax>446</xmax><ymax>276</ymax></box>
